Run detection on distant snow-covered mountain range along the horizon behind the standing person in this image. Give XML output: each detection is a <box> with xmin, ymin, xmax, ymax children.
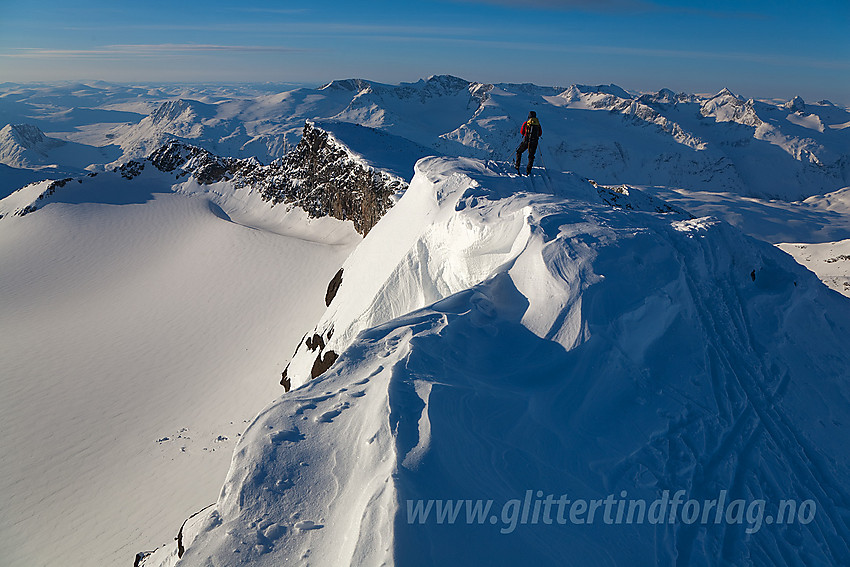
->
<box><xmin>3</xmin><ymin>76</ymin><xmax>850</xmax><ymax>199</ymax></box>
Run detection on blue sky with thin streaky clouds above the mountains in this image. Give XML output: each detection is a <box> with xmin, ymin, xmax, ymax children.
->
<box><xmin>0</xmin><ymin>0</ymin><xmax>850</xmax><ymax>105</ymax></box>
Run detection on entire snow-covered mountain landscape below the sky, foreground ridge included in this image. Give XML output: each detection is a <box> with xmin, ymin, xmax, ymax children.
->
<box><xmin>0</xmin><ymin>76</ymin><xmax>850</xmax><ymax>567</ymax></box>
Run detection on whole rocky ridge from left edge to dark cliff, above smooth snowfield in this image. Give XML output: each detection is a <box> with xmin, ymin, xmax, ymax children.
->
<box><xmin>0</xmin><ymin>123</ymin><xmax>407</xmax><ymax>234</ymax></box>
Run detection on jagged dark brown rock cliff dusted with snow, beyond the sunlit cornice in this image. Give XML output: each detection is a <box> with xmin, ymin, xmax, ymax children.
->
<box><xmin>148</xmin><ymin>122</ymin><xmax>407</xmax><ymax>235</ymax></box>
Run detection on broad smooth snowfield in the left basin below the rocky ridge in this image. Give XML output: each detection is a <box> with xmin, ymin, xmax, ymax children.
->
<box><xmin>0</xmin><ymin>168</ymin><xmax>359</xmax><ymax>567</ymax></box>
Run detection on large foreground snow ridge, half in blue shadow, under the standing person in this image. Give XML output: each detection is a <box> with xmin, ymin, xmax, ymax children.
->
<box><xmin>143</xmin><ymin>158</ymin><xmax>850</xmax><ymax>567</ymax></box>
